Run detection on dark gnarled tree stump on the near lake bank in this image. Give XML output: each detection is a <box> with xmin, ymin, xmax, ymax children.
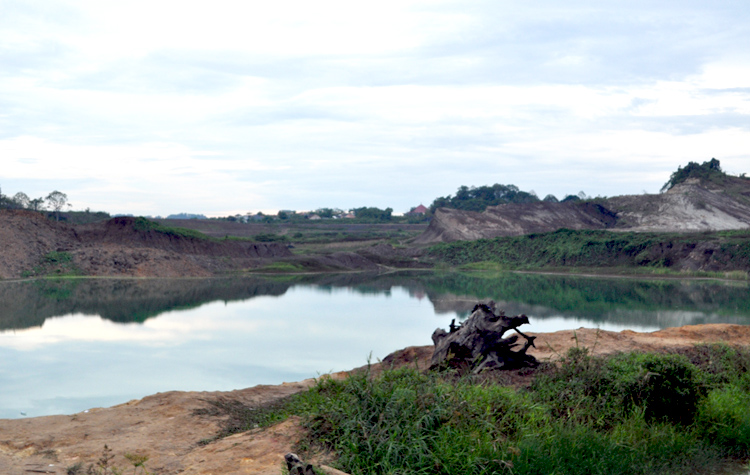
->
<box><xmin>430</xmin><ymin>301</ymin><xmax>539</xmax><ymax>373</ymax></box>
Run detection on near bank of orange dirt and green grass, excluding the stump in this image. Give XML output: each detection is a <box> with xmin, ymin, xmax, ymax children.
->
<box><xmin>0</xmin><ymin>325</ymin><xmax>750</xmax><ymax>475</ymax></box>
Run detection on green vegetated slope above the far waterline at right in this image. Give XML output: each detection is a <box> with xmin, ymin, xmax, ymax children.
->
<box><xmin>428</xmin><ymin>229</ymin><xmax>750</xmax><ymax>270</ymax></box>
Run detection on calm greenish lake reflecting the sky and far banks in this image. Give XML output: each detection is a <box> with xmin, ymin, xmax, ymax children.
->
<box><xmin>0</xmin><ymin>272</ymin><xmax>750</xmax><ymax>418</ymax></box>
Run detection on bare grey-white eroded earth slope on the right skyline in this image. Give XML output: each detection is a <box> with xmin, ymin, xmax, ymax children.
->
<box><xmin>415</xmin><ymin>177</ymin><xmax>750</xmax><ymax>244</ymax></box>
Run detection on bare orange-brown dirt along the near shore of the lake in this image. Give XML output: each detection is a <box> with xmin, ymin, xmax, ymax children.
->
<box><xmin>0</xmin><ymin>324</ymin><xmax>750</xmax><ymax>475</ymax></box>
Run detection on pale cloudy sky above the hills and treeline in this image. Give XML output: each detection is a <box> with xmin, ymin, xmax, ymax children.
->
<box><xmin>0</xmin><ymin>0</ymin><xmax>750</xmax><ymax>216</ymax></box>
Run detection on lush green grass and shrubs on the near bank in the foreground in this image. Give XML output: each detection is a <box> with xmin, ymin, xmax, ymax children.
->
<box><xmin>198</xmin><ymin>345</ymin><xmax>750</xmax><ymax>475</ymax></box>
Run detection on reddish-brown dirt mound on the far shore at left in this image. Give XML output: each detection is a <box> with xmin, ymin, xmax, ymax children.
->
<box><xmin>0</xmin><ymin>210</ymin><xmax>292</xmax><ymax>279</ymax></box>
